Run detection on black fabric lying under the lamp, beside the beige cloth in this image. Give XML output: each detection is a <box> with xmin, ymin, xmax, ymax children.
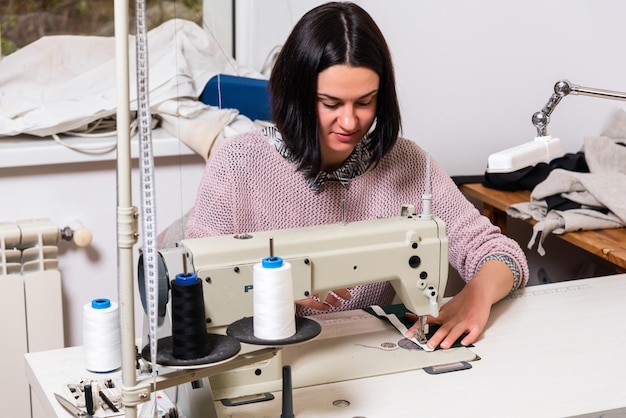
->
<box><xmin>483</xmin><ymin>151</ymin><xmax>589</xmax><ymax>192</ymax></box>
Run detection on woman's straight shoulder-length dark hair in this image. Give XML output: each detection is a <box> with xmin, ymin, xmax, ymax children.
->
<box><xmin>269</xmin><ymin>2</ymin><xmax>401</xmax><ymax>177</ymax></box>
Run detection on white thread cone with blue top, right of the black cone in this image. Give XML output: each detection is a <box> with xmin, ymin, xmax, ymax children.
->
<box><xmin>253</xmin><ymin>257</ymin><xmax>296</xmax><ymax>340</ymax></box>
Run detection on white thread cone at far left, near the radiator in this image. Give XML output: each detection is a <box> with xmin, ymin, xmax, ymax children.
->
<box><xmin>83</xmin><ymin>298</ymin><xmax>122</xmax><ymax>373</ymax></box>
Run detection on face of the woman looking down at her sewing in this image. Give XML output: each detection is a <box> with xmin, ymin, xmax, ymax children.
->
<box><xmin>317</xmin><ymin>65</ymin><xmax>380</xmax><ymax>171</ymax></box>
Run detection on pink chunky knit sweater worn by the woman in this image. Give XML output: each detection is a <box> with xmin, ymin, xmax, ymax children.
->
<box><xmin>186</xmin><ymin>130</ymin><xmax>528</xmax><ymax>315</ymax></box>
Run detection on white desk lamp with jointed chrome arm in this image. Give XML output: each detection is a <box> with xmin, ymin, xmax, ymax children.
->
<box><xmin>487</xmin><ymin>80</ymin><xmax>626</xmax><ymax>173</ymax></box>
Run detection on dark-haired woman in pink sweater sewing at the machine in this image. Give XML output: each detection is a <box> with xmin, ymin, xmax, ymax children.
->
<box><xmin>186</xmin><ymin>3</ymin><xmax>528</xmax><ymax>349</ymax></box>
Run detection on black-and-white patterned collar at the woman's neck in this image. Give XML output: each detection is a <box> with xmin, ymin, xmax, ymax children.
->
<box><xmin>263</xmin><ymin>126</ymin><xmax>372</xmax><ymax>192</ymax></box>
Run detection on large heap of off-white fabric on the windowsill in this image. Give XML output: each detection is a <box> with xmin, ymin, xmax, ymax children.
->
<box><xmin>0</xmin><ymin>19</ymin><xmax>264</xmax><ymax>158</ymax></box>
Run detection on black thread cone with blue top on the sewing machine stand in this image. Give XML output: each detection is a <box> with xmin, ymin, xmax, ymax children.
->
<box><xmin>172</xmin><ymin>273</ymin><xmax>211</xmax><ymax>360</ymax></box>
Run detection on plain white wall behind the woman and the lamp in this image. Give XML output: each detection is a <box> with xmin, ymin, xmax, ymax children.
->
<box><xmin>236</xmin><ymin>0</ymin><xmax>626</xmax><ymax>175</ymax></box>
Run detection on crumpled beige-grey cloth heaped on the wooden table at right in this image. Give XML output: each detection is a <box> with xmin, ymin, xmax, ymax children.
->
<box><xmin>507</xmin><ymin>110</ymin><xmax>626</xmax><ymax>255</ymax></box>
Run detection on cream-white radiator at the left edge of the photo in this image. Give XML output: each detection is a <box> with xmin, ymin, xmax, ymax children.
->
<box><xmin>0</xmin><ymin>219</ymin><xmax>64</xmax><ymax>418</ymax></box>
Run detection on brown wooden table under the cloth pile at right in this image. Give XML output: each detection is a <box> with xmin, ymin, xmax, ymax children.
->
<box><xmin>460</xmin><ymin>183</ymin><xmax>626</xmax><ymax>272</ymax></box>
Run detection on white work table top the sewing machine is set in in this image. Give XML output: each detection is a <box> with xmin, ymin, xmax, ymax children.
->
<box><xmin>26</xmin><ymin>274</ymin><xmax>626</xmax><ymax>418</ymax></box>
